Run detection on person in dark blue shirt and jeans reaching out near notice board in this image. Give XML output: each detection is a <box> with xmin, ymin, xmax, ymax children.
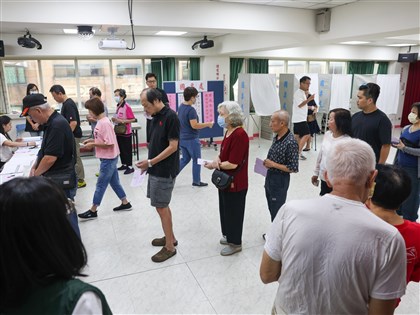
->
<box><xmin>178</xmin><ymin>87</ymin><xmax>213</xmax><ymax>187</ymax></box>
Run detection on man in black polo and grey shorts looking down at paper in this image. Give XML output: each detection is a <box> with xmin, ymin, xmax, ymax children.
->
<box><xmin>136</xmin><ymin>89</ymin><xmax>180</xmax><ymax>262</ymax></box>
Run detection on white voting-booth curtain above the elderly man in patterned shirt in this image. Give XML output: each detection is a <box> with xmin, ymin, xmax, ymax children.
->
<box><xmin>250</xmin><ymin>73</ymin><xmax>280</xmax><ymax>116</ymax></box>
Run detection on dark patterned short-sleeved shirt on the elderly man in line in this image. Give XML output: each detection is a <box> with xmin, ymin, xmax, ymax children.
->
<box><xmin>267</xmin><ymin>130</ymin><xmax>299</xmax><ymax>174</ymax></box>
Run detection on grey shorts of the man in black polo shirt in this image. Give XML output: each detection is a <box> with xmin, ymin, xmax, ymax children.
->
<box><xmin>147</xmin><ymin>174</ymin><xmax>175</xmax><ymax>208</ymax></box>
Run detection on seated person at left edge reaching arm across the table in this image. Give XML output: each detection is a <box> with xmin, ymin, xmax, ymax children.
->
<box><xmin>0</xmin><ymin>115</ymin><xmax>36</xmax><ymax>170</ymax></box>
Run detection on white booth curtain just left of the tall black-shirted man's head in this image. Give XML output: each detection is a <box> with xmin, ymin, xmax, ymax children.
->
<box><xmin>330</xmin><ymin>74</ymin><xmax>352</xmax><ymax>110</ymax></box>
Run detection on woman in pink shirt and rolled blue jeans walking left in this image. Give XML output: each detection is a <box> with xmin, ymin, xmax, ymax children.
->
<box><xmin>78</xmin><ymin>97</ymin><xmax>132</xmax><ymax>219</ymax></box>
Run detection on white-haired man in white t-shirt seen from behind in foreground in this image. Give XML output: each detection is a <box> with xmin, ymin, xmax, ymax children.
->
<box><xmin>260</xmin><ymin>139</ymin><xmax>406</xmax><ymax>314</ymax></box>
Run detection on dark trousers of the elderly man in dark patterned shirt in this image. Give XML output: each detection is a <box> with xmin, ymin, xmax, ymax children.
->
<box><xmin>264</xmin><ymin>171</ymin><xmax>290</xmax><ymax>222</ymax></box>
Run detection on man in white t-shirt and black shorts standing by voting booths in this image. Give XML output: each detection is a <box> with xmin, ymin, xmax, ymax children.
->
<box><xmin>292</xmin><ymin>76</ymin><xmax>315</xmax><ymax>160</ymax></box>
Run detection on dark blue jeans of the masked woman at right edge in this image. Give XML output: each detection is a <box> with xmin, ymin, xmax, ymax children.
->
<box><xmin>397</xmin><ymin>165</ymin><xmax>420</xmax><ymax>222</ymax></box>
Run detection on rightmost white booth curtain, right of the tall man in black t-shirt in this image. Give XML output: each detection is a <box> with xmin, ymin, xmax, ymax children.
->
<box><xmin>376</xmin><ymin>74</ymin><xmax>400</xmax><ymax>115</ymax></box>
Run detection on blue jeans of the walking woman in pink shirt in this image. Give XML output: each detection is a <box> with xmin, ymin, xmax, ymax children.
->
<box><xmin>93</xmin><ymin>156</ymin><xmax>126</xmax><ymax>206</ymax></box>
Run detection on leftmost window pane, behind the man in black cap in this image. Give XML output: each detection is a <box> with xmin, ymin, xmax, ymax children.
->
<box><xmin>3</xmin><ymin>60</ymin><xmax>41</xmax><ymax>113</ymax></box>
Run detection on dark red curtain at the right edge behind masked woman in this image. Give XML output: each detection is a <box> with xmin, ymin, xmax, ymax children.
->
<box><xmin>401</xmin><ymin>61</ymin><xmax>420</xmax><ymax>127</ymax></box>
